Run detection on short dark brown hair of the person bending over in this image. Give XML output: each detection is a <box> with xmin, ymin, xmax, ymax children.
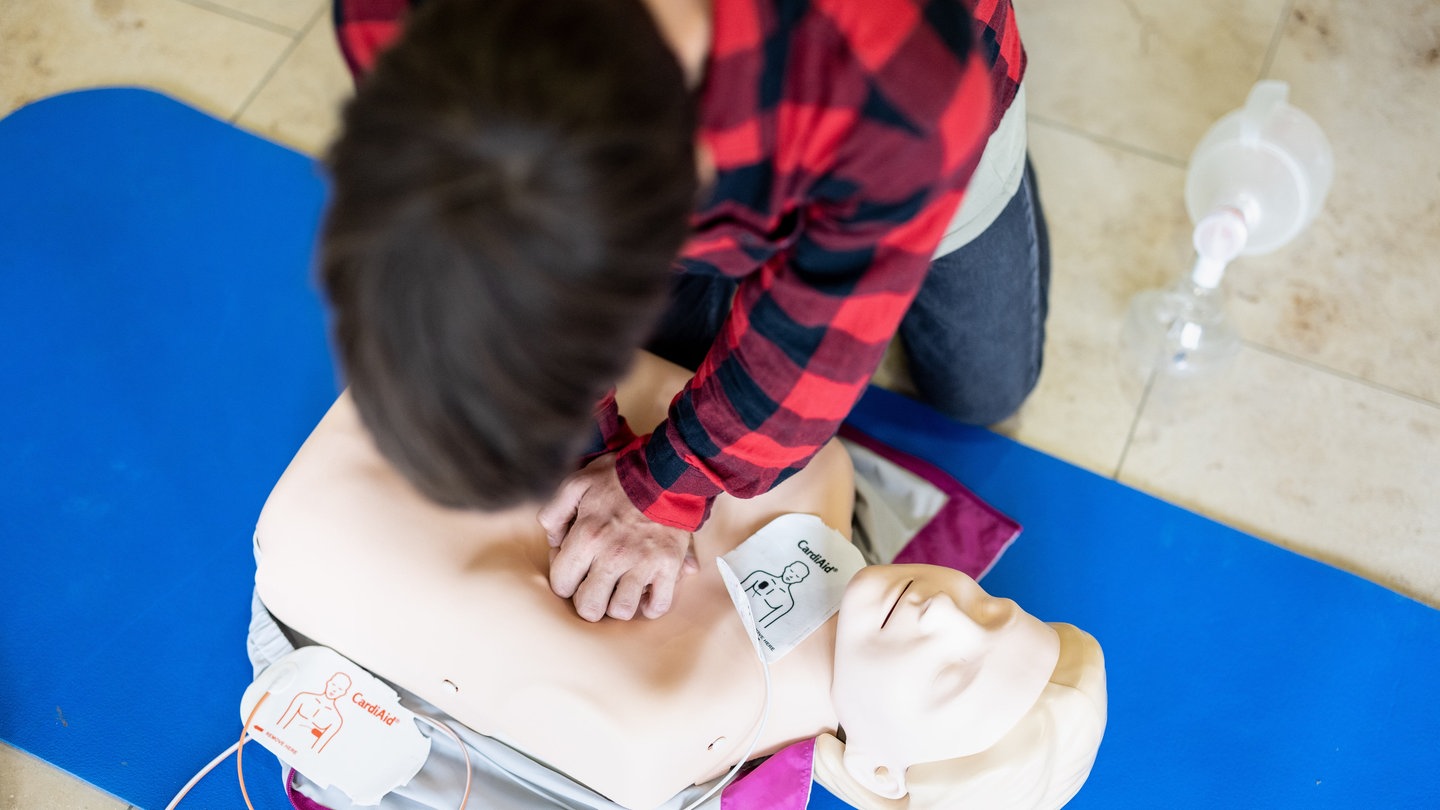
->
<box><xmin>321</xmin><ymin>0</ymin><xmax>696</xmax><ymax>507</ymax></box>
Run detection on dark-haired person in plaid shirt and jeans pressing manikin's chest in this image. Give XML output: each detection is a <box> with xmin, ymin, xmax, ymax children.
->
<box><xmin>321</xmin><ymin>0</ymin><xmax>1048</xmax><ymax>621</ymax></box>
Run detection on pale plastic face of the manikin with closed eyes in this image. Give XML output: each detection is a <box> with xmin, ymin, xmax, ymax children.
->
<box><xmin>832</xmin><ymin>565</ymin><xmax>1060</xmax><ymax>778</ymax></box>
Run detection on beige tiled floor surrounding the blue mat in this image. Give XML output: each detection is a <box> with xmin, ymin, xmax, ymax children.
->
<box><xmin>0</xmin><ymin>0</ymin><xmax>1440</xmax><ymax>795</ymax></box>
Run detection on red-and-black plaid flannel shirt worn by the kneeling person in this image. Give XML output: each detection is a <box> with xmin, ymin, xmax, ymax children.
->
<box><xmin>336</xmin><ymin>0</ymin><xmax>1025</xmax><ymax>530</ymax></box>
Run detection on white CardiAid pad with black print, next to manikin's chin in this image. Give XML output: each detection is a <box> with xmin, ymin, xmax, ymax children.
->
<box><xmin>719</xmin><ymin>515</ymin><xmax>865</xmax><ymax>663</ymax></box>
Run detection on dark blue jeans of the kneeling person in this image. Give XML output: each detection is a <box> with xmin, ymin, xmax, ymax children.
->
<box><xmin>645</xmin><ymin>159</ymin><xmax>1050</xmax><ymax>425</ymax></box>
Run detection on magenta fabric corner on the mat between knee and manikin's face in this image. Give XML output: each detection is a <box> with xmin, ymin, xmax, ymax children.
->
<box><xmin>840</xmin><ymin>425</ymin><xmax>1020</xmax><ymax>579</ymax></box>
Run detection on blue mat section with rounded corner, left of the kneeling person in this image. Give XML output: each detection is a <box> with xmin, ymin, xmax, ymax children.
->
<box><xmin>0</xmin><ymin>91</ymin><xmax>337</xmax><ymax>810</ymax></box>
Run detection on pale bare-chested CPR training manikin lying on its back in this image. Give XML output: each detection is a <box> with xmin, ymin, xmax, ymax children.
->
<box><xmin>256</xmin><ymin>350</ymin><xmax>1103</xmax><ymax>809</ymax></box>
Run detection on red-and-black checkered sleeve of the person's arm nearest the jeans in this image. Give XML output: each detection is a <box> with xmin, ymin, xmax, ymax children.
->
<box><xmin>616</xmin><ymin>0</ymin><xmax>992</xmax><ymax>529</ymax></box>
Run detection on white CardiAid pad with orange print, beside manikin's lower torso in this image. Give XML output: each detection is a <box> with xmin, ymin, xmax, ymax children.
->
<box><xmin>240</xmin><ymin>646</ymin><xmax>431</xmax><ymax>804</ymax></box>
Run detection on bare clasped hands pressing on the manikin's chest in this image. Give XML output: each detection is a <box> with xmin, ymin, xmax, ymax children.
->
<box><xmin>537</xmin><ymin>454</ymin><xmax>698</xmax><ymax>621</ymax></box>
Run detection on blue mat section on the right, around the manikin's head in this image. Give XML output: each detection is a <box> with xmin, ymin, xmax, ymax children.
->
<box><xmin>851</xmin><ymin>389</ymin><xmax>1440</xmax><ymax>810</ymax></box>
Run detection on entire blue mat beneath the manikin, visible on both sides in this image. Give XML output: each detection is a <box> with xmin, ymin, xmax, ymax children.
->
<box><xmin>0</xmin><ymin>91</ymin><xmax>1440</xmax><ymax>810</ymax></box>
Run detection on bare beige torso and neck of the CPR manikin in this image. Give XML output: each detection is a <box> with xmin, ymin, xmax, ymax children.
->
<box><xmin>256</xmin><ymin>356</ymin><xmax>852</xmax><ymax>807</ymax></box>
